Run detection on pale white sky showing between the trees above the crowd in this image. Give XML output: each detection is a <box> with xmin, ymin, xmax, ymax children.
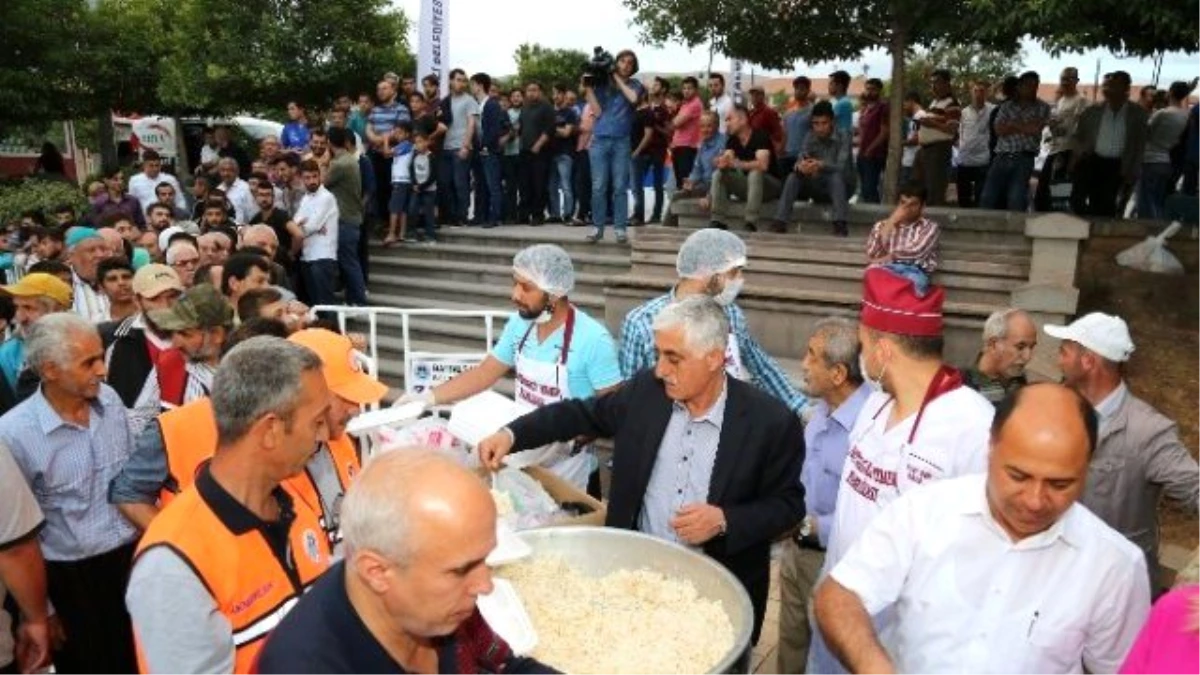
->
<box><xmin>394</xmin><ymin>0</ymin><xmax>1200</xmax><ymax>85</ymax></box>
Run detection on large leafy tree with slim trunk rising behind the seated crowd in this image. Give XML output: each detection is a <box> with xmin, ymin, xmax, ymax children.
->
<box><xmin>624</xmin><ymin>0</ymin><xmax>1027</xmax><ymax>199</ymax></box>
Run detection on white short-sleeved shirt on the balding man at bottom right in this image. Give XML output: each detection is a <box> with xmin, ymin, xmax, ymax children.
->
<box><xmin>832</xmin><ymin>476</ymin><xmax>1150</xmax><ymax>675</ymax></box>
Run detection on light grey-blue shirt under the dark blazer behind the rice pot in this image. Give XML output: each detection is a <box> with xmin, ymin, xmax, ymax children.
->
<box><xmin>637</xmin><ymin>386</ymin><xmax>728</xmax><ymax>544</ymax></box>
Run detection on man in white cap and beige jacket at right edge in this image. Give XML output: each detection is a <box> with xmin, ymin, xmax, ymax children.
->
<box><xmin>1045</xmin><ymin>312</ymin><xmax>1200</xmax><ymax>592</ymax></box>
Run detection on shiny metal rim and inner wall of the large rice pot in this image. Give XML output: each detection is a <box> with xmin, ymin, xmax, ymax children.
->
<box><xmin>521</xmin><ymin>526</ymin><xmax>754</xmax><ymax>675</ymax></box>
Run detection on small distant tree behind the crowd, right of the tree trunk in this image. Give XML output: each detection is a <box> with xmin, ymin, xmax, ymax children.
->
<box><xmin>904</xmin><ymin>42</ymin><xmax>1025</xmax><ymax>104</ymax></box>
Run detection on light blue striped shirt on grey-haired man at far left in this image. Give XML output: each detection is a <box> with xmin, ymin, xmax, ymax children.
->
<box><xmin>0</xmin><ymin>384</ymin><xmax>138</xmax><ymax>561</ymax></box>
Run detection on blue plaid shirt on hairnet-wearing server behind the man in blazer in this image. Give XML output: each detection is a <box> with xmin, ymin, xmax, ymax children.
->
<box><xmin>618</xmin><ymin>289</ymin><xmax>808</xmax><ymax>413</ymax></box>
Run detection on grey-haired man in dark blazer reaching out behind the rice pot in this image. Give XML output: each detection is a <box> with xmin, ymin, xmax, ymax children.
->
<box><xmin>479</xmin><ymin>295</ymin><xmax>804</xmax><ymax>641</ymax></box>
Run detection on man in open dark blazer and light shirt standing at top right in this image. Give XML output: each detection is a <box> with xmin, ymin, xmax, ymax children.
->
<box><xmin>1070</xmin><ymin>71</ymin><xmax>1150</xmax><ymax>217</ymax></box>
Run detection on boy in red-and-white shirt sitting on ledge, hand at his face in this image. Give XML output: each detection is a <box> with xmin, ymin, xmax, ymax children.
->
<box><xmin>866</xmin><ymin>184</ymin><xmax>940</xmax><ymax>297</ymax></box>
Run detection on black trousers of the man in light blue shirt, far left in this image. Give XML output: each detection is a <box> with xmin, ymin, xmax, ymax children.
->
<box><xmin>46</xmin><ymin>544</ymin><xmax>138</xmax><ymax>675</ymax></box>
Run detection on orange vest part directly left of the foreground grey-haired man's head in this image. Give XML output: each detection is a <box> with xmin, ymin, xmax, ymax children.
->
<box><xmin>158</xmin><ymin>396</ymin><xmax>217</xmax><ymax>507</ymax></box>
